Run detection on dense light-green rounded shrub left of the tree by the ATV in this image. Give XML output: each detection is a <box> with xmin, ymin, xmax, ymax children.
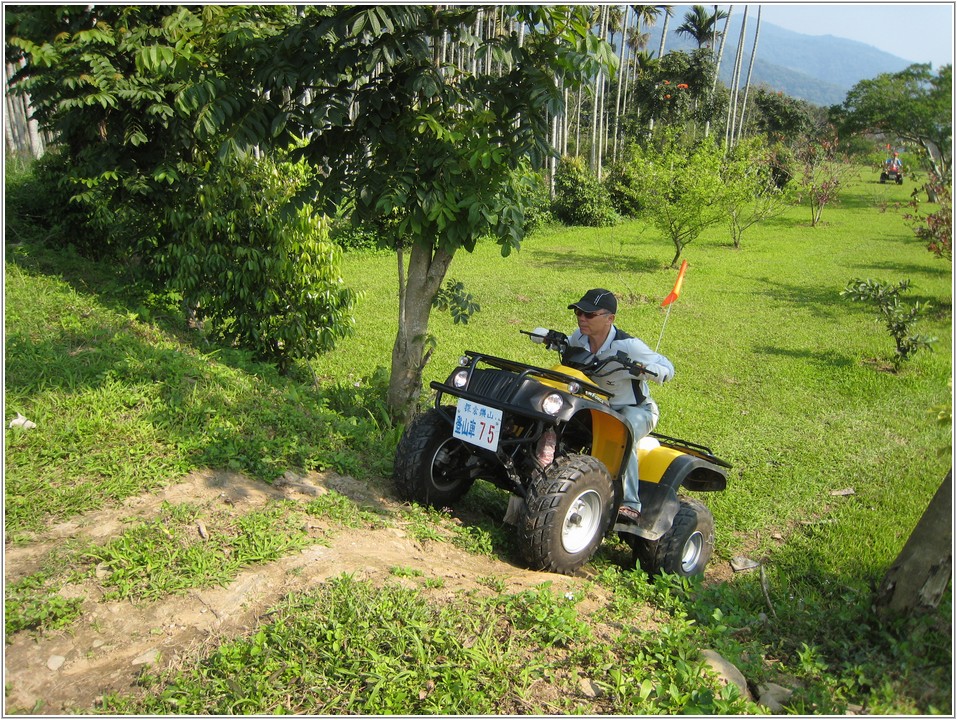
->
<box><xmin>160</xmin><ymin>158</ymin><xmax>355</xmax><ymax>369</ymax></box>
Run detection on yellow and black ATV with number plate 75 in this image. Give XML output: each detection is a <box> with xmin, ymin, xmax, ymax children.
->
<box><xmin>394</xmin><ymin>328</ymin><xmax>731</xmax><ymax>576</ymax></box>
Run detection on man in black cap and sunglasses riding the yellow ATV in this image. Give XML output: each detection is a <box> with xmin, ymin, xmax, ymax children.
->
<box><xmin>568</xmin><ymin>288</ymin><xmax>675</xmax><ymax>522</ymax></box>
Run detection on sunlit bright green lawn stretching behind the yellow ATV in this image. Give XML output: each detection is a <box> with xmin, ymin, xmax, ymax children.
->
<box><xmin>317</xmin><ymin>176</ymin><xmax>951</xmax><ymax>576</ymax></box>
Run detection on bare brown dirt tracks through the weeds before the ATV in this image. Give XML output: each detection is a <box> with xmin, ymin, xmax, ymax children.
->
<box><xmin>4</xmin><ymin>473</ymin><xmax>602</xmax><ymax>715</ymax></box>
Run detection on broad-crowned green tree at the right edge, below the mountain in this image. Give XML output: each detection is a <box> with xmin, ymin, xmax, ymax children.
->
<box><xmin>831</xmin><ymin>63</ymin><xmax>953</xmax><ymax>180</ymax></box>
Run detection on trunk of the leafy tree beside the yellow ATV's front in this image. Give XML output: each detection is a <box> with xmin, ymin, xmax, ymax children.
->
<box><xmin>388</xmin><ymin>241</ymin><xmax>453</xmax><ymax>423</ymax></box>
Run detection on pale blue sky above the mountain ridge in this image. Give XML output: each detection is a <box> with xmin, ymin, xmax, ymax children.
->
<box><xmin>756</xmin><ymin>2</ymin><xmax>954</xmax><ymax>68</ymax></box>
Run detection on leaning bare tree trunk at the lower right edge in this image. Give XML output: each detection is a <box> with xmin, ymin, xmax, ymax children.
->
<box><xmin>874</xmin><ymin>469</ymin><xmax>954</xmax><ymax>614</ymax></box>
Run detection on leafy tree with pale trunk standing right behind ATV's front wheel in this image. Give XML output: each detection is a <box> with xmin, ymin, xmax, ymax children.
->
<box><xmin>243</xmin><ymin>5</ymin><xmax>615</xmax><ymax>419</ymax></box>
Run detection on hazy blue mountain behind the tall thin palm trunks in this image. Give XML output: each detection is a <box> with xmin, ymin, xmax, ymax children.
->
<box><xmin>648</xmin><ymin>5</ymin><xmax>912</xmax><ymax>106</ymax></box>
